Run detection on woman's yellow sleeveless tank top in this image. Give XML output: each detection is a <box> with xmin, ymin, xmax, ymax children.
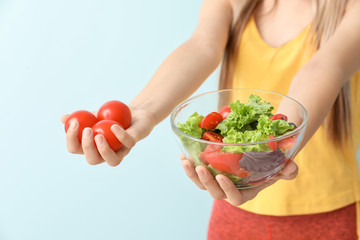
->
<box><xmin>232</xmin><ymin>14</ymin><xmax>360</xmax><ymax>222</ymax></box>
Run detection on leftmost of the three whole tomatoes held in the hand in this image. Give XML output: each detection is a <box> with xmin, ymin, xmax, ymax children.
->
<box><xmin>65</xmin><ymin>110</ymin><xmax>97</xmax><ymax>142</ymax></box>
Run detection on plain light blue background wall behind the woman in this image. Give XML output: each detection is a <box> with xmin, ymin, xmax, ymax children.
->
<box><xmin>0</xmin><ymin>0</ymin><xmax>217</xmax><ymax>240</ymax></box>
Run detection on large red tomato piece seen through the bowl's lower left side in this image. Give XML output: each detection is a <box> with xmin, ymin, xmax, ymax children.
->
<box><xmin>200</xmin><ymin>152</ymin><xmax>250</xmax><ymax>177</ymax></box>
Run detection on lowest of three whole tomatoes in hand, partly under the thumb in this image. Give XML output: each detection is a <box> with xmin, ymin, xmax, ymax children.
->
<box><xmin>92</xmin><ymin>120</ymin><xmax>122</xmax><ymax>152</ymax></box>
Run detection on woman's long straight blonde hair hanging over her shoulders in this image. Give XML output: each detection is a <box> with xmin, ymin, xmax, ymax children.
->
<box><xmin>219</xmin><ymin>0</ymin><xmax>352</xmax><ymax>144</ymax></box>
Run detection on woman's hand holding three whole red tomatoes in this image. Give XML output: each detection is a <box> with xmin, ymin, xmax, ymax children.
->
<box><xmin>61</xmin><ymin>107</ymin><xmax>155</xmax><ymax>167</ymax></box>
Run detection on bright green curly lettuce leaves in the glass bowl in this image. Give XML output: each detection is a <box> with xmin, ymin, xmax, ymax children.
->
<box><xmin>177</xmin><ymin>95</ymin><xmax>294</xmax><ymax>153</ymax></box>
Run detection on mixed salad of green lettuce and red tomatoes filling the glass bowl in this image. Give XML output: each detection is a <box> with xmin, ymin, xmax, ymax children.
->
<box><xmin>177</xmin><ymin>95</ymin><xmax>296</xmax><ymax>188</ymax></box>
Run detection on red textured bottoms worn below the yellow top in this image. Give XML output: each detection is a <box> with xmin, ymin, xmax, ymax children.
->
<box><xmin>208</xmin><ymin>200</ymin><xmax>358</xmax><ymax>240</ymax></box>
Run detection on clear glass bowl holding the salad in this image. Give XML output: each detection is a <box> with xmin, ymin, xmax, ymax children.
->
<box><xmin>170</xmin><ymin>89</ymin><xmax>308</xmax><ymax>189</ymax></box>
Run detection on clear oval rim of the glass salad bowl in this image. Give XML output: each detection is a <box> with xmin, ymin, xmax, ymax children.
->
<box><xmin>170</xmin><ymin>88</ymin><xmax>308</xmax><ymax>146</ymax></box>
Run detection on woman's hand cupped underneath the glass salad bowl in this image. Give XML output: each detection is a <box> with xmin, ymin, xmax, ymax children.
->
<box><xmin>180</xmin><ymin>154</ymin><xmax>298</xmax><ymax>206</ymax></box>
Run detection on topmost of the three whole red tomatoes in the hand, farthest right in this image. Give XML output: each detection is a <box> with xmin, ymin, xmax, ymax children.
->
<box><xmin>97</xmin><ymin>100</ymin><xmax>132</xmax><ymax>129</ymax></box>
